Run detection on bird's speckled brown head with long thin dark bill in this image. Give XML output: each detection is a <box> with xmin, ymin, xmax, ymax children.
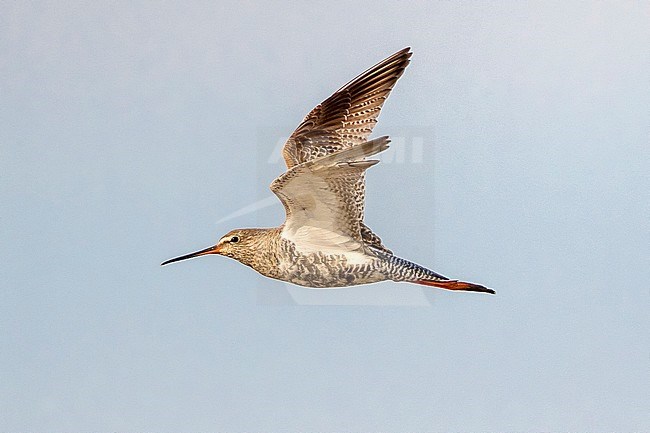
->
<box><xmin>161</xmin><ymin>229</ymin><xmax>266</xmax><ymax>266</ymax></box>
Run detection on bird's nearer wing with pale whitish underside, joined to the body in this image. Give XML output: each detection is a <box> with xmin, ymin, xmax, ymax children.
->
<box><xmin>271</xmin><ymin>137</ymin><xmax>390</xmax><ymax>251</ymax></box>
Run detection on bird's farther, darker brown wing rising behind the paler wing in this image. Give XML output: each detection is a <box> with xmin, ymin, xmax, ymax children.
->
<box><xmin>282</xmin><ymin>48</ymin><xmax>412</xmax><ymax>168</ymax></box>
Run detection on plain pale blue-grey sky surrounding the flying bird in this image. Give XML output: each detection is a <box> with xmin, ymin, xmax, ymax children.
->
<box><xmin>0</xmin><ymin>1</ymin><xmax>650</xmax><ymax>432</ymax></box>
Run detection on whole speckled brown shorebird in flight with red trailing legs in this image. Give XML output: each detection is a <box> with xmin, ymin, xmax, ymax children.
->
<box><xmin>162</xmin><ymin>48</ymin><xmax>494</xmax><ymax>293</ymax></box>
